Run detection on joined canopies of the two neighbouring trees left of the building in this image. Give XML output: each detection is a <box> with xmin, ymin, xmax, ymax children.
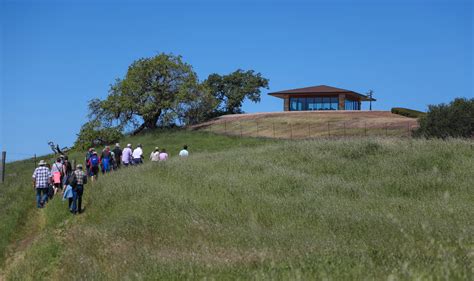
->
<box><xmin>79</xmin><ymin>53</ymin><xmax>268</xmax><ymax>143</ymax></box>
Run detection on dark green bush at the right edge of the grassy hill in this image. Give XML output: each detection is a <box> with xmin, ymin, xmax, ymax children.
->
<box><xmin>414</xmin><ymin>98</ymin><xmax>474</xmax><ymax>139</ymax></box>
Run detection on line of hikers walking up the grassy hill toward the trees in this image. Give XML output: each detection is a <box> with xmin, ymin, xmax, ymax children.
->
<box><xmin>33</xmin><ymin>143</ymin><xmax>189</xmax><ymax>214</ymax></box>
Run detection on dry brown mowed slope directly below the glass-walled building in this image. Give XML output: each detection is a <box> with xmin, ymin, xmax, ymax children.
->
<box><xmin>193</xmin><ymin>111</ymin><xmax>418</xmax><ymax>139</ymax></box>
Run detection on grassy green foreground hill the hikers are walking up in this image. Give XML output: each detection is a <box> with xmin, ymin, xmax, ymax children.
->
<box><xmin>0</xmin><ymin>131</ymin><xmax>474</xmax><ymax>280</ymax></box>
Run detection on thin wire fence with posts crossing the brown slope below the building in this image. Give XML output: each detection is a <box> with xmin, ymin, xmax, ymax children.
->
<box><xmin>202</xmin><ymin>120</ymin><xmax>418</xmax><ymax>139</ymax></box>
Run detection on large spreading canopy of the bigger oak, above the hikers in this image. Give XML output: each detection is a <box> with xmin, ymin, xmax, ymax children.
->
<box><xmin>89</xmin><ymin>54</ymin><xmax>199</xmax><ymax>133</ymax></box>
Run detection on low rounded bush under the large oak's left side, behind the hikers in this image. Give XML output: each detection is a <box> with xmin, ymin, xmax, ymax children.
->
<box><xmin>74</xmin><ymin>118</ymin><xmax>123</xmax><ymax>150</ymax></box>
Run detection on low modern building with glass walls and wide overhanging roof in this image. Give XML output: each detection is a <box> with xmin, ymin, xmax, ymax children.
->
<box><xmin>269</xmin><ymin>85</ymin><xmax>375</xmax><ymax>111</ymax></box>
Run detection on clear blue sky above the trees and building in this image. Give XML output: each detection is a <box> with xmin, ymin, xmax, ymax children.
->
<box><xmin>0</xmin><ymin>0</ymin><xmax>474</xmax><ymax>160</ymax></box>
